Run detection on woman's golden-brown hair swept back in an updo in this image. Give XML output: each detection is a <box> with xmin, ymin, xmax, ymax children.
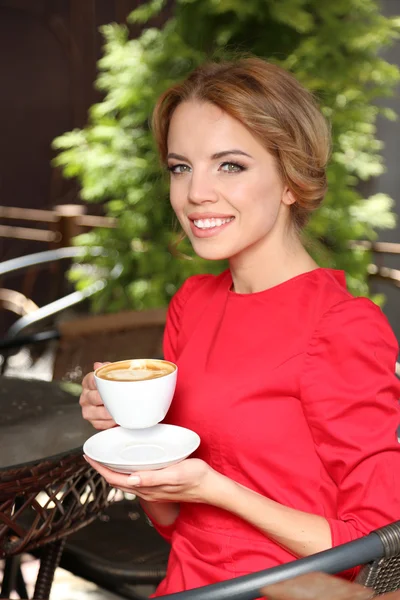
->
<box><xmin>152</xmin><ymin>58</ymin><xmax>330</xmax><ymax>229</ymax></box>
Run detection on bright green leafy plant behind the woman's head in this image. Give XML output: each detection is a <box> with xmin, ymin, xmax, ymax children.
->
<box><xmin>54</xmin><ymin>0</ymin><xmax>400</xmax><ymax>311</ymax></box>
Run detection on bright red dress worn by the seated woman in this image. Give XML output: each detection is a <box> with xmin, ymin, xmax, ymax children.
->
<box><xmin>149</xmin><ymin>269</ymin><xmax>400</xmax><ymax>596</ymax></box>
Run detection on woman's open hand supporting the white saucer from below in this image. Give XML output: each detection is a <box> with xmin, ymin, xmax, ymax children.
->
<box><xmin>85</xmin><ymin>456</ymin><xmax>223</xmax><ymax>504</ymax></box>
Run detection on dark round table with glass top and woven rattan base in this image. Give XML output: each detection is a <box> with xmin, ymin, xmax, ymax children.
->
<box><xmin>0</xmin><ymin>377</ymin><xmax>113</xmax><ymax>599</ymax></box>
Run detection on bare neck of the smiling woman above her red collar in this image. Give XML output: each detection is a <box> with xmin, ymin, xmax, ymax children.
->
<box><xmin>229</xmin><ymin>221</ymin><xmax>318</xmax><ymax>294</ymax></box>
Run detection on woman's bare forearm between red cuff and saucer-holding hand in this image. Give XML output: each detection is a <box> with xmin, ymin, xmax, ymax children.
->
<box><xmin>211</xmin><ymin>474</ymin><xmax>332</xmax><ymax>557</ymax></box>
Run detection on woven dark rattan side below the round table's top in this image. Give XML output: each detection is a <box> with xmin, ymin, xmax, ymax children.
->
<box><xmin>0</xmin><ymin>450</ymin><xmax>115</xmax><ymax>558</ymax></box>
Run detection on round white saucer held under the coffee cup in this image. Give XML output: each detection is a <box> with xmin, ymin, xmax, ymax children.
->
<box><xmin>83</xmin><ymin>423</ymin><xmax>200</xmax><ymax>473</ymax></box>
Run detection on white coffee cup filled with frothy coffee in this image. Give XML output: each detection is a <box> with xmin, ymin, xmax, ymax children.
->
<box><xmin>94</xmin><ymin>358</ymin><xmax>178</xmax><ymax>429</ymax></box>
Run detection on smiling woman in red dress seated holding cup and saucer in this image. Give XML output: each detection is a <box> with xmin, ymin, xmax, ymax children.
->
<box><xmin>80</xmin><ymin>58</ymin><xmax>400</xmax><ymax>595</ymax></box>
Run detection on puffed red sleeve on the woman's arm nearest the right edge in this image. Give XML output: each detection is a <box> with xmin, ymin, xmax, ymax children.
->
<box><xmin>301</xmin><ymin>298</ymin><xmax>400</xmax><ymax>546</ymax></box>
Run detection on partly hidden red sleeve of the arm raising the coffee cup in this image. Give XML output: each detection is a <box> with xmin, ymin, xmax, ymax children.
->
<box><xmin>142</xmin><ymin>275</ymin><xmax>211</xmax><ymax>543</ymax></box>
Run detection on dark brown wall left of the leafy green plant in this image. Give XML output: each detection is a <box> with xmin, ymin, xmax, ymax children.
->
<box><xmin>0</xmin><ymin>0</ymin><xmax>144</xmax><ymax>260</ymax></box>
